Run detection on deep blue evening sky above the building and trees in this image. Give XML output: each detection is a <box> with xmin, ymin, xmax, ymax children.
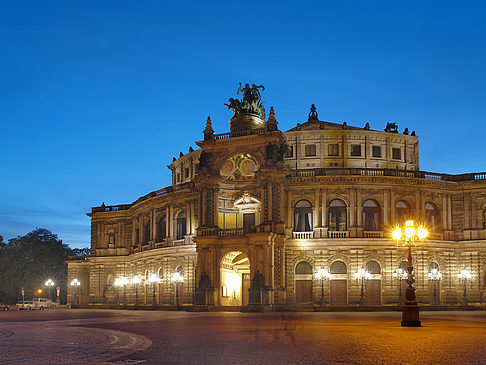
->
<box><xmin>0</xmin><ymin>1</ymin><xmax>486</xmax><ymax>247</ymax></box>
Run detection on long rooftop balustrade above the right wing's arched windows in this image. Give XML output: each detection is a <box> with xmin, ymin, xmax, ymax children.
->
<box><xmin>290</xmin><ymin>168</ymin><xmax>486</xmax><ymax>182</ymax></box>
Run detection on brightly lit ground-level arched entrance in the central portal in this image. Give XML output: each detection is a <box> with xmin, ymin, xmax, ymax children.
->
<box><xmin>220</xmin><ymin>251</ymin><xmax>250</xmax><ymax>306</ymax></box>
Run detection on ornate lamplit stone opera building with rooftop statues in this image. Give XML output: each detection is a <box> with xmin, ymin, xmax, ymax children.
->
<box><xmin>68</xmin><ymin>85</ymin><xmax>486</xmax><ymax>308</ymax></box>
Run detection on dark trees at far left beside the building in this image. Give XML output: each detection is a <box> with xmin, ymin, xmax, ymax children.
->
<box><xmin>0</xmin><ymin>228</ymin><xmax>89</xmax><ymax>304</ymax></box>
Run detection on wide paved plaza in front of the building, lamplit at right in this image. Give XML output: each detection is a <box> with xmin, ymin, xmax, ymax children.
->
<box><xmin>0</xmin><ymin>310</ymin><xmax>486</xmax><ymax>364</ymax></box>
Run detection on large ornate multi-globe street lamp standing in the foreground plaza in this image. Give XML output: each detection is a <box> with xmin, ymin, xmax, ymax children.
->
<box><xmin>392</xmin><ymin>220</ymin><xmax>429</xmax><ymax>327</ymax></box>
